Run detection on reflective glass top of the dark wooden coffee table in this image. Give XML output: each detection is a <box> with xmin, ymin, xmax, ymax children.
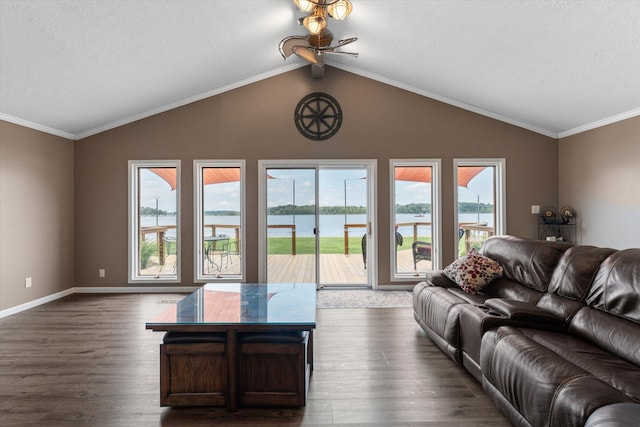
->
<box><xmin>147</xmin><ymin>283</ymin><xmax>316</xmax><ymax>329</ymax></box>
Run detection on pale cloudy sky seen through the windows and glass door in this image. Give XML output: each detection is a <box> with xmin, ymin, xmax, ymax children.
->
<box><xmin>141</xmin><ymin>168</ymin><xmax>493</xmax><ymax>212</ymax></box>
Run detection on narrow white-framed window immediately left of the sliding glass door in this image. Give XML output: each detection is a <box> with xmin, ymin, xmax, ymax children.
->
<box><xmin>193</xmin><ymin>160</ymin><xmax>245</xmax><ymax>281</ymax></box>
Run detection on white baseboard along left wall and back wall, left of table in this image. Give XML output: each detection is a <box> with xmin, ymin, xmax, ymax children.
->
<box><xmin>0</xmin><ymin>286</ymin><xmax>200</xmax><ymax>319</ymax></box>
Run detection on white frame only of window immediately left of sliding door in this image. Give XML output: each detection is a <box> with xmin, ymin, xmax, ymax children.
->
<box><xmin>193</xmin><ymin>159</ymin><xmax>247</xmax><ymax>283</ymax></box>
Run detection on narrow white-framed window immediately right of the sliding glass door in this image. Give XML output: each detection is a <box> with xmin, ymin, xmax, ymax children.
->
<box><xmin>389</xmin><ymin>160</ymin><xmax>441</xmax><ymax>280</ymax></box>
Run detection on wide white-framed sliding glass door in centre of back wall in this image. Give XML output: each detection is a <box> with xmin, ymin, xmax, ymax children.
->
<box><xmin>259</xmin><ymin>160</ymin><xmax>376</xmax><ymax>287</ymax></box>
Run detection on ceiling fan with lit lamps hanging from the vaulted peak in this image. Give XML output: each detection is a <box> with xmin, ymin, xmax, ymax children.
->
<box><xmin>278</xmin><ymin>0</ymin><xmax>358</xmax><ymax>78</ymax></box>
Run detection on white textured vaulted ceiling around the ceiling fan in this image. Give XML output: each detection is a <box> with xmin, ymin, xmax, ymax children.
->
<box><xmin>0</xmin><ymin>0</ymin><xmax>640</xmax><ymax>139</ymax></box>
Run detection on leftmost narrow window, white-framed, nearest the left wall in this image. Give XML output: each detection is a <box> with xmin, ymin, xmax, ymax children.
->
<box><xmin>129</xmin><ymin>160</ymin><xmax>180</xmax><ymax>283</ymax></box>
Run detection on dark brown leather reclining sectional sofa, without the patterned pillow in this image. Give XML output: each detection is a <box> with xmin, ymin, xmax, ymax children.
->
<box><xmin>413</xmin><ymin>236</ymin><xmax>640</xmax><ymax>427</ymax></box>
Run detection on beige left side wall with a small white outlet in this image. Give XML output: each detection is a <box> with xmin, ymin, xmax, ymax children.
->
<box><xmin>0</xmin><ymin>121</ymin><xmax>73</xmax><ymax>310</ymax></box>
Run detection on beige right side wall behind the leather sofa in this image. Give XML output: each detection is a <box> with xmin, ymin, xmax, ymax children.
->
<box><xmin>559</xmin><ymin>117</ymin><xmax>640</xmax><ymax>249</ymax></box>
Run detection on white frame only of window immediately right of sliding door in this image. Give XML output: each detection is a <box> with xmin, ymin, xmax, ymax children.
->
<box><xmin>389</xmin><ymin>159</ymin><xmax>442</xmax><ymax>282</ymax></box>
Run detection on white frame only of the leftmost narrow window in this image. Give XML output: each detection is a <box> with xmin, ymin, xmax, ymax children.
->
<box><xmin>127</xmin><ymin>160</ymin><xmax>182</xmax><ymax>284</ymax></box>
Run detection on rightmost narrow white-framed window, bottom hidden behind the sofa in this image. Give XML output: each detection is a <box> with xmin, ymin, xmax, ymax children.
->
<box><xmin>454</xmin><ymin>159</ymin><xmax>506</xmax><ymax>257</ymax></box>
